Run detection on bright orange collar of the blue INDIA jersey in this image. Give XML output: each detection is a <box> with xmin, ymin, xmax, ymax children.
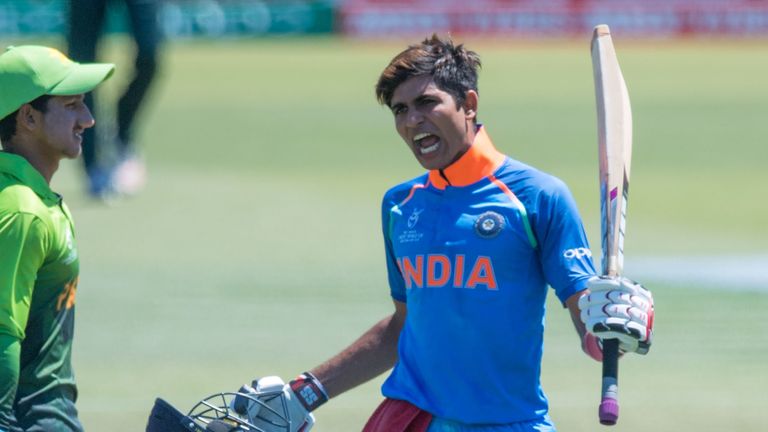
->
<box><xmin>429</xmin><ymin>126</ymin><xmax>506</xmax><ymax>189</ymax></box>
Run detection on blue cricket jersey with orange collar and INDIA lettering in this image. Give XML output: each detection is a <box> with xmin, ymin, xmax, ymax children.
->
<box><xmin>382</xmin><ymin>127</ymin><xmax>595</xmax><ymax>424</ymax></box>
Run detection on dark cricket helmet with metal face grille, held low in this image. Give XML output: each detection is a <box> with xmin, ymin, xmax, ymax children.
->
<box><xmin>146</xmin><ymin>385</ymin><xmax>291</xmax><ymax>432</ymax></box>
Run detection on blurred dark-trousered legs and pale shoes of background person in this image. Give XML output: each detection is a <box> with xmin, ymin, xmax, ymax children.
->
<box><xmin>67</xmin><ymin>0</ymin><xmax>161</xmax><ymax>199</ymax></box>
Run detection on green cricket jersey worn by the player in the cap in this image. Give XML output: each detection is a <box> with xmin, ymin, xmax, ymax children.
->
<box><xmin>0</xmin><ymin>152</ymin><xmax>82</xmax><ymax>431</ymax></box>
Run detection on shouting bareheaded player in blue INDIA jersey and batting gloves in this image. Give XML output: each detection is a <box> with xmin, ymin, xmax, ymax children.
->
<box><xmin>230</xmin><ymin>36</ymin><xmax>653</xmax><ymax>432</ymax></box>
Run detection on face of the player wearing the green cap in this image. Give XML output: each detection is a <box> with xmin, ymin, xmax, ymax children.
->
<box><xmin>36</xmin><ymin>94</ymin><xmax>96</xmax><ymax>159</ymax></box>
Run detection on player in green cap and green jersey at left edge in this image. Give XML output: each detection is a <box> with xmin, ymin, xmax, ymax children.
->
<box><xmin>0</xmin><ymin>45</ymin><xmax>114</xmax><ymax>432</ymax></box>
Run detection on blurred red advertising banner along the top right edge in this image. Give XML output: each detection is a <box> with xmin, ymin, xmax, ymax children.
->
<box><xmin>338</xmin><ymin>0</ymin><xmax>768</xmax><ymax>37</ymax></box>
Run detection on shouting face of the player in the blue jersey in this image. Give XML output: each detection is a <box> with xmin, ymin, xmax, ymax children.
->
<box><xmin>390</xmin><ymin>75</ymin><xmax>477</xmax><ymax>170</ymax></box>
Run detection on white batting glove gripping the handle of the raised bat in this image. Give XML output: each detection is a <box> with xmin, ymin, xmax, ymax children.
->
<box><xmin>579</xmin><ymin>276</ymin><xmax>653</xmax><ymax>354</ymax></box>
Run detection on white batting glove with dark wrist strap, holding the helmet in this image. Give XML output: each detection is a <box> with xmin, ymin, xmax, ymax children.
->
<box><xmin>233</xmin><ymin>372</ymin><xmax>328</xmax><ymax>432</ymax></box>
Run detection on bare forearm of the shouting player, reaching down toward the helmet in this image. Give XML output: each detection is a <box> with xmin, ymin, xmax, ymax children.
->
<box><xmin>311</xmin><ymin>304</ymin><xmax>405</xmax><ymax>398</ymax></box>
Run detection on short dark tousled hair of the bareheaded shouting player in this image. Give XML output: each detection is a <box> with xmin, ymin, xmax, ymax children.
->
<box><xmin>376</xmin><ymin>34</ymin><xmax>481</xmax><ymax>108</ymax></box>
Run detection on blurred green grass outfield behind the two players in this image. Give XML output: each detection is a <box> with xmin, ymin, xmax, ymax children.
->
<box><xmin>7</xmin><ymin>35</ymin><xmax>768</xmax><ymax>432</ymax></box>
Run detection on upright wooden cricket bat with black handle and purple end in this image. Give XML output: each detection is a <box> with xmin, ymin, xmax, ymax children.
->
<box><xmin>591</xmin><ymin>24</ymin><xmax>632</xmax><ymax>425</ymax></box>
